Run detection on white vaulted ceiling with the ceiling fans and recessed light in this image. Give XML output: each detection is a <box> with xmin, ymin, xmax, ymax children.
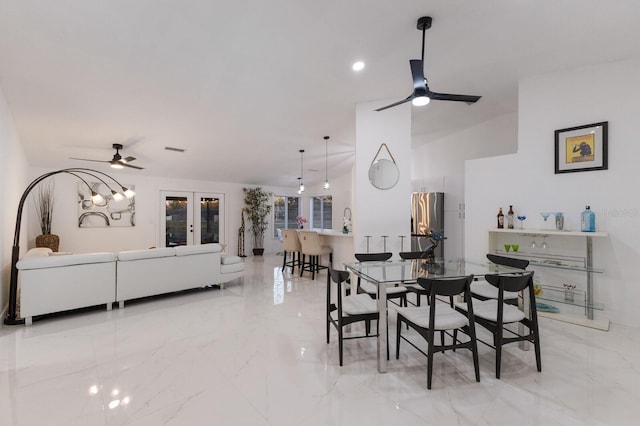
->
<box><xmin>0</xmin><ymin>0</ymin><xmax>640</xmax><ymax>187</ymax></box>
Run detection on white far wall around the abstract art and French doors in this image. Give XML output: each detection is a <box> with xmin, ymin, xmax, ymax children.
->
<box><xmin>24</xmin><ymin>169</ymin><xmax>351</xmax><ymax>255</ymax></box>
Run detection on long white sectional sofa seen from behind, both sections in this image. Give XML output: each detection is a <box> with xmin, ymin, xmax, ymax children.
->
<box><xmin>16</xmin><ymin>243</ymin><xmax>244</xmax><ymax>325</ymax></box>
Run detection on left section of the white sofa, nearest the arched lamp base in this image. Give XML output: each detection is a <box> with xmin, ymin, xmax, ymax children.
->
<box><xmin>16</xmin><ymin>248</ymin><xmax>116</xmax><ymax>325</ymax></box>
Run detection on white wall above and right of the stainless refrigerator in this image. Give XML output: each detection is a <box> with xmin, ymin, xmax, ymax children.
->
<box><xmin>411</xmin><ymin>113</ymin><xmax>518</xmax><ymax>259</ymax></box>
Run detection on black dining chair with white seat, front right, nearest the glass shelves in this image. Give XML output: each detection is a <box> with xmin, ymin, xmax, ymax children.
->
<box><xmin>455</xmin><ymin>271</ymin><xmax>542</xmax><ymax>379</ymax></box>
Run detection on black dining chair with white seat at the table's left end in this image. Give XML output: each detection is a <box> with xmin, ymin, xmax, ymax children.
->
<box><xmin>326</xmin><ymin>264</ymin><xmax>380</xmax><ymax>366</ymax></box>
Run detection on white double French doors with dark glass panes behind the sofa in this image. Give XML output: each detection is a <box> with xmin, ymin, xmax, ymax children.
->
<box><xmin>160</xmin><ymin>191</ymin><xmax>225</xmax><ymax>247</ymax></box>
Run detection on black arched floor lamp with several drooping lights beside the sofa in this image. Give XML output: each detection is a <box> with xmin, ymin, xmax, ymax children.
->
<box><xmin>4</xmin><ymin>167</ymin><xmax>135</xmax><ymax>325</ymax></box>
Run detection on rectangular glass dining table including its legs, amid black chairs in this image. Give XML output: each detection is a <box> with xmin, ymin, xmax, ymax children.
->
<box><xmin>344</xmin><ymin>259</ymin><xmax>522</xmax><ymax>373</ymax></box>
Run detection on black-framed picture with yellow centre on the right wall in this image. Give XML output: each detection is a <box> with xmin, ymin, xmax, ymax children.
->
<box><xmin>555</xmin><ymin>121</ymin><xmax>609</xmax><ymax>174</ymax></box>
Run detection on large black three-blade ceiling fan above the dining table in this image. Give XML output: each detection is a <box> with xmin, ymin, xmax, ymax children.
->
<box><xmin>376</xmin><ymin>16</ymin><xmax>482</xmax><ymax>111</ymax></box>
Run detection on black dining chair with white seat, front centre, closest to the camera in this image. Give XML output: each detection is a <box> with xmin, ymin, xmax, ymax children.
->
<box><xmin>396</xmin><ymin>275</ymin><xmax>480</xmax><ymax>389</ymax></box>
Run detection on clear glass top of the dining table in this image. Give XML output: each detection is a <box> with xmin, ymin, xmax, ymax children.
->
<box><xmin>344</xmin><ymin>259</ymin><xmax>522</xmax><ymax>284</ymax></box>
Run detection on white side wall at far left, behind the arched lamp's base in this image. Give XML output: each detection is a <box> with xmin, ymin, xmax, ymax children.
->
<box><xmin>0</xmin><ymin>90</ymin><xmax>28</xmax><ymax>319</ymax></box>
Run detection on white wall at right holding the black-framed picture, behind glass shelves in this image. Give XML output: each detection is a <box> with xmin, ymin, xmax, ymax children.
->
<box><xmin>465</xmin><ymin>59</ymin><xmax>640</xmax><ymax>325</ymax></box>
